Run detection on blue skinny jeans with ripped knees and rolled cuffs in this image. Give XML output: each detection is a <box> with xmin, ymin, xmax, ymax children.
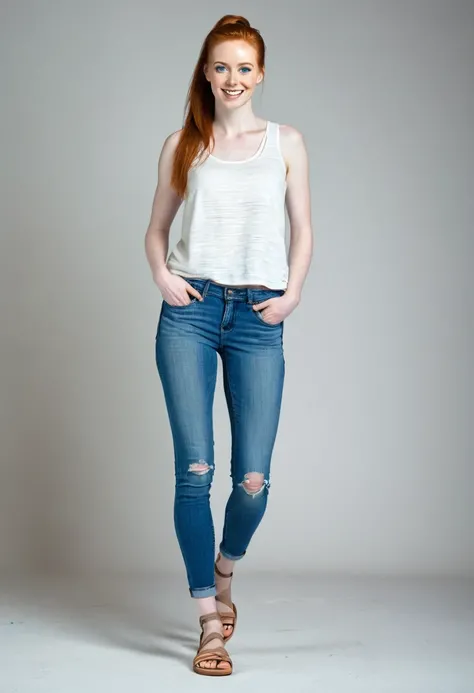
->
<box><xmin>156</xmin><ymin>279</ymin><xmax>285</xmax><ymax>597</ymax></box>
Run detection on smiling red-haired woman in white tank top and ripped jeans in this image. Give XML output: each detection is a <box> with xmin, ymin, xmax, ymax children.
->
<box><xmin>145</xmin><ymin>15</ymin><xmax>312</xmax><ymax>676</ymax></box>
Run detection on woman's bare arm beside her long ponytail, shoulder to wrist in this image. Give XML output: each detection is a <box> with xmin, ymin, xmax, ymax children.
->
<box><xmin>145</xmin><ymin>132</ymin><xmax>182</xmax><ymax>284</ymax></box>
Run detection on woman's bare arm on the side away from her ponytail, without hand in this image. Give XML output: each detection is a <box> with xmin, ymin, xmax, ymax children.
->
<box><xmin>281</xmin><ymin>125</ymin><xmax>313</xmax><ymax>304</ymax></box>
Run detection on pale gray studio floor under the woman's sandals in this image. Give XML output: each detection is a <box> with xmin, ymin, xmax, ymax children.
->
<box><xmin>0</xmin><ymin>574</ymin><xmax>474</xmax><ymax>693</ymax></box>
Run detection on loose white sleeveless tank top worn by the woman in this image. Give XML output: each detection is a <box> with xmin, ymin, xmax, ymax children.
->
<box><xmin>167</xmin><ymin>121</ymin><xmax>288</xmax><ymax>289</ymax></box>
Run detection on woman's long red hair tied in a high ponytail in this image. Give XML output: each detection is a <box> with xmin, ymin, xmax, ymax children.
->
<box><xmin>171</xmin><ymin>14</ymin><xmax>265</xmax><ymax>197</ymax></box>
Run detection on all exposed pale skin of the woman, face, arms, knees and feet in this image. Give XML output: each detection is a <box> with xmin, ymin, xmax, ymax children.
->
<box><xmin>145</xmin><ymin>40</ymin><xmax>313</xmax><ymax>668</ymax></box>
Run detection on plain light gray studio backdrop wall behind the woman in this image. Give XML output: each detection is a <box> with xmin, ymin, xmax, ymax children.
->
<box><xmin>0</xmin><ymin>0</ymin><xmax>474</xmax><ymax>574</ymax></box>
